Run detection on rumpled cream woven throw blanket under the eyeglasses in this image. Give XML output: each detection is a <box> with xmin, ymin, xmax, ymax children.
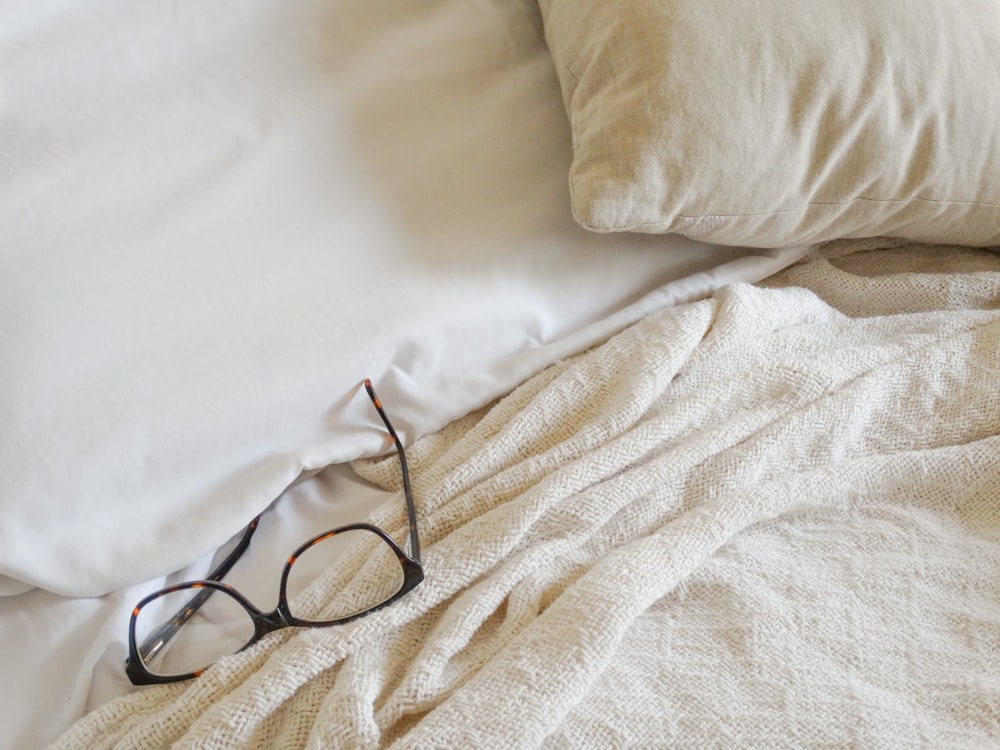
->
<box><xmin>52</xmin><ymin>243</ymin><xmax>1000</xmax><ymax>750</ymax></box>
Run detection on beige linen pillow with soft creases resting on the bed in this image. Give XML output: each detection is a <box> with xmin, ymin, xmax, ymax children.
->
<box><xmin>541</xmin><ymin>0</ymin><xmax>1000</xmax><ymax>251</ymax></box>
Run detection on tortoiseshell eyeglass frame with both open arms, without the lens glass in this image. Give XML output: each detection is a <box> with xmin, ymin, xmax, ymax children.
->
<box><xmin>125</xmin><ymin>379</ymin><xmax>424</xmax><ymax>685</ymax></box>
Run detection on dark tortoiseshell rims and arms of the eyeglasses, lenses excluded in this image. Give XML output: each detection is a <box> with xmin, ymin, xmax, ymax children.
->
<box><xmin>125</xmin><ymin>378</ymin><xmax>424</xmax><ymax>685</ymax></box>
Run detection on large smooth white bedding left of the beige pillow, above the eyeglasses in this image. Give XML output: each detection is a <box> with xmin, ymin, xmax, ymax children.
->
<box><xmin>0</xmin><ymin>0</ymin><xmax>793</xmax><ymax>595</ymax></box>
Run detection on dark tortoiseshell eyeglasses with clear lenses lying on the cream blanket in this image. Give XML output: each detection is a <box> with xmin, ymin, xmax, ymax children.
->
<box><xmin>125</xmin><ymin>380</ymin><xmax>424</xmax><ymax>685</ymax></box>
